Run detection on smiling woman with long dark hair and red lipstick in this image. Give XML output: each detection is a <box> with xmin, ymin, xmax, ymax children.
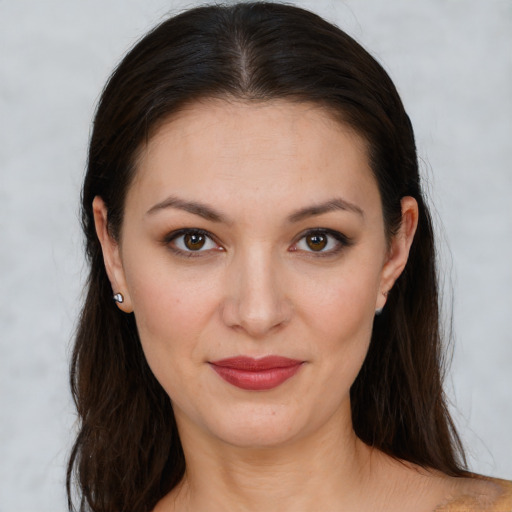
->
<box><xmin>68</xmin><ymin>3</ymin><xmax>512</xmax><ymax>512</ymax></box>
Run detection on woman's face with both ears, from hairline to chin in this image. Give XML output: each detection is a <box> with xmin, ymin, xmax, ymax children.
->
<box><xmin>94</xmin><ymin>100</ymin><xmax>415</xmax><ymax>446</ymax></box>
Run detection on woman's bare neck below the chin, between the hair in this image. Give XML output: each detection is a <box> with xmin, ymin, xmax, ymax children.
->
<box><xmin>164</xmin><ymin>406</ymin><xmax>372</xmax><ymax>512</ymax></box>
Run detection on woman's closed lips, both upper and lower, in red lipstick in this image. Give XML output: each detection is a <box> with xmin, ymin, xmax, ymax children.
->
<box><xmin>210</xmin><ymin>356</ymin><xmax>303</xmax><ymax>391</ymax></box>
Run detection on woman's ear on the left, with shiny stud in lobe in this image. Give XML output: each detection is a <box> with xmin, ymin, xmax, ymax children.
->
<box><xmin>92</xmin><ymin>196</ymin><xmax>133</xmax><ymax>313</ymax></box>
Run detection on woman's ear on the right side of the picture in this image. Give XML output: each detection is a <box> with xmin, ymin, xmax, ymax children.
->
<box><xmin>376</xmin><ymin>196</ymin><xmax>418</xmax><ymax>309</ymax></box>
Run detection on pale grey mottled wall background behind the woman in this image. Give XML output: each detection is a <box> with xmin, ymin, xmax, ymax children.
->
<box><xmin>0</xmin><ymin>0</ymin><xmax>512</xmax><ymax>512</ymax></box>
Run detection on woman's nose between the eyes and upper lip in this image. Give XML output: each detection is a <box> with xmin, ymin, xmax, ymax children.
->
<box><xmin>222</xmin><ymin>248</ymin><xmax>293</xmax><ymax>338</ymax></box>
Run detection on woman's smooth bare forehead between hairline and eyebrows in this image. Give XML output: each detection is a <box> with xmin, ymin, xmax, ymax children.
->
<box><xmin>128</xmin><ymin>100</ymin><xmax>380</xmax><ymax>218</ymax></box>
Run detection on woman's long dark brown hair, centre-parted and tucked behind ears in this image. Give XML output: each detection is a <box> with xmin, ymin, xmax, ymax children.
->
<box><xmin>67</xmin><ymin>3</ymin><xmax>464</xmax><ymax>512</ymax></box>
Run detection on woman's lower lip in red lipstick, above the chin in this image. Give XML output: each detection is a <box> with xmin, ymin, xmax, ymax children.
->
<box><xmin>211</xmin><ymin>363</ymin><xmax>302</xmax><ymax>391</ymax></box>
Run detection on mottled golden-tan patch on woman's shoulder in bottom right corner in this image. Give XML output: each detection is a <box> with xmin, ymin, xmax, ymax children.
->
<box><xmin>434</xmin><ymin>475</ymin><xmax>512</xmax><ymax>512</ymax></box>
